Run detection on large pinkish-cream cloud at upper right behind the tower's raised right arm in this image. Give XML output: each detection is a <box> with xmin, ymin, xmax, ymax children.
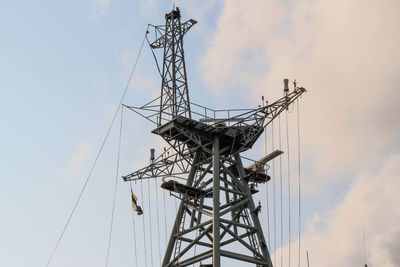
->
<box><xmin>202</xmin><ymin>0</ymin><xmax>400</xmax><ymax>182</ymax></box>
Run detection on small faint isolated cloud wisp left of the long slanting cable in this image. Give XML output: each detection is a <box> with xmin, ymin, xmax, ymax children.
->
<box><xmin>59</xmin><ymin>142</ymin><xmax>93</xmax><ymax>178</ymax></box>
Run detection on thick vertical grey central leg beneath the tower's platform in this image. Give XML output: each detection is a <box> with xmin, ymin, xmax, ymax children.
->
<box><xmin>212</xmin><ymin>137</ymin><xmax>221</xmax><ymax>267</ymax></box>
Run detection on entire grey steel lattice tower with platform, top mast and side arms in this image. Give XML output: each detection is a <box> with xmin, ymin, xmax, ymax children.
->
<box><xmin>123</xmin><ymin>9</ymin><xmax>305</xmax><ymax>267</ymax></box>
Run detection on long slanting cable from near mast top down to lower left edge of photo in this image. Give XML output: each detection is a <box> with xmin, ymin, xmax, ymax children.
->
<box><xmin>46</xmin><ymin>31</ymin><xmax>146</xmax><ymax>267</ymax></box>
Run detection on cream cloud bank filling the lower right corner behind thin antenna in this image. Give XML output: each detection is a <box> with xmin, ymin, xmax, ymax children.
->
<box><xmin>277</xmin><ymin>154</ymin><xmax>400</xmax><ymax>267</ymax></box>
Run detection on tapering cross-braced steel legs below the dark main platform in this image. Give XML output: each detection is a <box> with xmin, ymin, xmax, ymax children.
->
<box><xmin>162</xmin><ymin>144</ymin><xmax>272</xmax><ymax>267</ymax></box>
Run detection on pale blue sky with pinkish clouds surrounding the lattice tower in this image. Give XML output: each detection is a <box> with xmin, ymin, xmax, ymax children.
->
<box><xmin>0</xmin><ymin>0</ymin><xmax>400</xmax><ymax>267</ymax></box>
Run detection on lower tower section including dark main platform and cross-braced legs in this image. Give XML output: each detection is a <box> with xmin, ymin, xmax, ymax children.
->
<box><xmin>158</xmin><ymin>118</ymin><xmax>272</xmax><ymax>267</ymax></box>
